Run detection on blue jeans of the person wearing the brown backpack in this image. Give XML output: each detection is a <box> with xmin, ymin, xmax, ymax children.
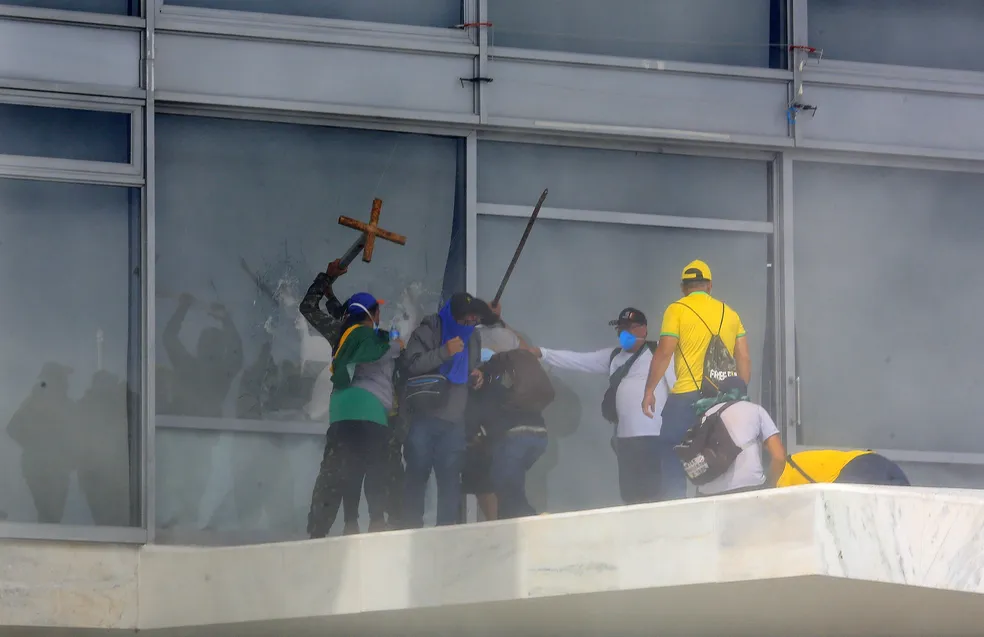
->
<box><xmin>490</xmin><ymin>433</ymin><xmax>547</xmax><ymax>520</ymax></box>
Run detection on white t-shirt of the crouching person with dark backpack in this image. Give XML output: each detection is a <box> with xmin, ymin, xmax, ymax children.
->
<box><xmin>699</xmin><ymin>400</ymin><xmax>779</xmax><ymax>495</ymax></box>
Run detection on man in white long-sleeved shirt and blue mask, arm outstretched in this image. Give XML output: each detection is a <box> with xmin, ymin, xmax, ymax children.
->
<box><xmin>533</xmin><ymin>307</ymin><xmax>676</xmax><ymax>504</ymax></box>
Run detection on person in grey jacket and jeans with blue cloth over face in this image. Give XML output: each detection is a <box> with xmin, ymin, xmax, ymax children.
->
<box><xmin>400</xmin><ymin>292</ymin><xmax>499</xmax><ymax>528</ymax></box>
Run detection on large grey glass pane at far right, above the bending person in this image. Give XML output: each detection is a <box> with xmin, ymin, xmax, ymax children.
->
<box><xmin>794</xmin><ymin>163</ymin><xmax>984</xmax><ymax>453</ymax></box>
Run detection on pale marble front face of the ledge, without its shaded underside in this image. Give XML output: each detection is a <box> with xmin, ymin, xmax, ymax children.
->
<box><xmin>0</xmin><ymin>485</ymin><xmax>984</xmax><ymax>630</ymax></box>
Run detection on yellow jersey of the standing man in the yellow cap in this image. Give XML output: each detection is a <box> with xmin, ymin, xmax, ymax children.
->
<box><xmin>659</xmin><ymin>292</ymin><xmax>745</xmax><ymax>394</ymax></box>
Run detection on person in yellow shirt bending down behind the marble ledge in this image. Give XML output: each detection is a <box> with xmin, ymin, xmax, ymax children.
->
<box><xmin>776</xmin><ymin>449</ymin><xmax>909</xmax><ymax>487</ymax></box>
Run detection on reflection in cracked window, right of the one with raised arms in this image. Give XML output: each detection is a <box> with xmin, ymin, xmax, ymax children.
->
<box><xmin>232</xmin><ymin>341</ymin><xmax>304</xmax><ymax>533</ymax></box>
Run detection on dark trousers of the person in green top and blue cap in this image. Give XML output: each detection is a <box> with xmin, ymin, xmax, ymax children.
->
<box><xmin>307</xmin><ymin>420</ymin><xmax>390</xmax><ymax>538</ymax></box>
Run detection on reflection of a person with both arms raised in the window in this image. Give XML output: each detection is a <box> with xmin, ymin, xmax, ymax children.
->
<box><xmin>158</xmin><ymin>293</ymin><xmax>243</xmax><ymax>528</ymax></box>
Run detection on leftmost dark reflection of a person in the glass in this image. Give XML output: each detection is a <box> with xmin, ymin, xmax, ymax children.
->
<box><xmin>7</xmin><ymin>362</ymin><xmax>75</xmax><ymax>524</ymax></box>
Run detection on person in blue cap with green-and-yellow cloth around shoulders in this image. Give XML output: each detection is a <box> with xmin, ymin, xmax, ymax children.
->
<box><xmin>308</xmin><ymin>292</ymin><xmax>402</xmax><ymax>538</ymax></box>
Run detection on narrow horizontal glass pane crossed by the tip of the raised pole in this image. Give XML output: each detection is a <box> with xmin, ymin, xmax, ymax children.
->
<box><xmin>478</xmin><ymin>142</ymin><xmax>769</xmax><ymax>221</ymax></box>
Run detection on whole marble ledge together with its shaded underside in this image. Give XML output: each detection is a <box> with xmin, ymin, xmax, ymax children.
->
<box><xmin>0</xmin><ymin>485</ymin><xmax>984</xmax><ymax>637</ymax></box>
